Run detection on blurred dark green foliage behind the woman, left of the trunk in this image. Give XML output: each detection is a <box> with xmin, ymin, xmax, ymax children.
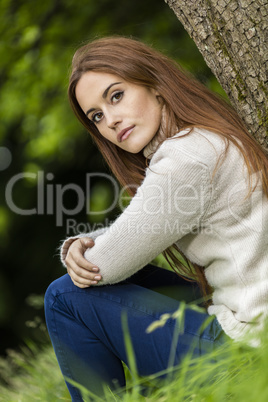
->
<box><xmin>0</xmin><ymin>0</ymin><xmax>222</xmax><ymax>353</ymax></box>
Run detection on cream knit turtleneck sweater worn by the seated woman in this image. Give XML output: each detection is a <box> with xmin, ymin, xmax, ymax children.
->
<box><xmin>61</xmin><ymin>129</ymin><xmax>268</xmax><ymax>339</ymax></box>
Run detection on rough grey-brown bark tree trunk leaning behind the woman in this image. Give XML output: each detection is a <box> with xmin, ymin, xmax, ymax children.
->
<box><xmin>165</xmin><ymin>0</ymin><xmax>268</xmax><ymax>150</ymax></box>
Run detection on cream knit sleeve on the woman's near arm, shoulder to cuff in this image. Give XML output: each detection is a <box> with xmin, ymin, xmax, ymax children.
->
<box><xmin>80</xmin><ymin>141</ymin><xmax>211</xmax><ymax>286</ymax></box>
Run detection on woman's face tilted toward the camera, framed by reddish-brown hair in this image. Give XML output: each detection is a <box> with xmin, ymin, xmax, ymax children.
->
<box><xmin>76</xmin><ymin>71</ymin><xmax>162</xmax><ymax>153</ymax></box>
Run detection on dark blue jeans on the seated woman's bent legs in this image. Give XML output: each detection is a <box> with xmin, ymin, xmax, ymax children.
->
<box><xmin>45</xmin><ymin>265</ymin><xmax>226</xmax><ymax>401</ymax></box>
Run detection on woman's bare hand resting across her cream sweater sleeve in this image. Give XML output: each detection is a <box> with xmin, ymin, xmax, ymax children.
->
<box><xmin>65</xmin><ymin>237</ymin><xmax>101</xmax><ymax>288</ymax></box>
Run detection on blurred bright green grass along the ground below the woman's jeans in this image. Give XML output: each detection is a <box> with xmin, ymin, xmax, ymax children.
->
<box><xmin>0</xmin><ymin>320</ymin><xmax>268</xmax><ymax>402</ymax></box>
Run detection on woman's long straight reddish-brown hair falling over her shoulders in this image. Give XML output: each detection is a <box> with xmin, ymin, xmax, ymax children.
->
<box><xmin>68</xmin><ymin>37</ymin><xmax>268</xmax><ymax>302</ymax></box>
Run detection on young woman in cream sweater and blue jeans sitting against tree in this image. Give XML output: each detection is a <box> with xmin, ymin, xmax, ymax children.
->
<box><xmin>45</xmin><ymin>37</ymin><xmax>268</xmax><ymax>401</ymax></box>
